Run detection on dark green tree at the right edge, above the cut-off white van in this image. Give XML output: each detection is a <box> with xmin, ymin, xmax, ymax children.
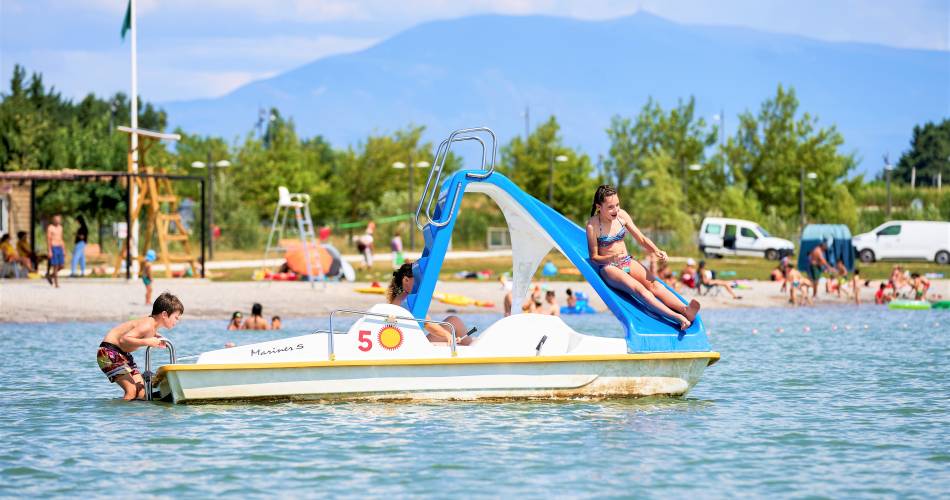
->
<box><xmin>893</xmin><ymin>118</ymin><xmax>950</xmax><ymax>186</ymax></box>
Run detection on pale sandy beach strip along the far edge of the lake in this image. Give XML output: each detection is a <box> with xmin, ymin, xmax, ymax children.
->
<box><xmin>0</xmin><ymin>278</ymin><xmax>950</xmax><ymax>323</ymax></box>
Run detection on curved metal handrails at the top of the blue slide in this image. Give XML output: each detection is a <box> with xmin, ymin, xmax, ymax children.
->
<box><xmin>415</xmin><ymin>127</ymin><xmax>498</xmax><ymax>230</ymax></box>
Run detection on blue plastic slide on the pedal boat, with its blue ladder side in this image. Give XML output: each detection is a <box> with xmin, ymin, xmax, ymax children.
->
<box><xmin>407</xmin><ymin>170</ymin><xmax>710</xmax><ymax>352</ymax></box>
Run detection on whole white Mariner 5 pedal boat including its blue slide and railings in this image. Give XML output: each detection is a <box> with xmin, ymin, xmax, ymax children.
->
<box><xmin>144</xmin><ymin>129</ymin><xmax>719</xmax><ymax>403</ymax></box>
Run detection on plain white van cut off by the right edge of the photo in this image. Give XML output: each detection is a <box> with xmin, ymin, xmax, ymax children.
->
<box><xmin>851</xmin><ymin>220</ymin><xmax>950</xmax><ymax>264</ymax></box>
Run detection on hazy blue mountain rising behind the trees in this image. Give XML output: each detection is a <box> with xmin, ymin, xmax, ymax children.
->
<box><xmin>163</xmin><ymin>13</ymin><xmax>950</xmax><ymax>174</ymax></box>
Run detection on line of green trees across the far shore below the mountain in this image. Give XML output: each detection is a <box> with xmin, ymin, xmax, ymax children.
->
<box><xmin>0</xmin><ymin>66</ymin><xmax>950</xmax><ymax>254</ymax></box>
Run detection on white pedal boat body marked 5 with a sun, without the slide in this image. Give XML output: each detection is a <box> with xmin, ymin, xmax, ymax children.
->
<box><xmin>151</xmin><ymin>304</ymin><xmax>719</xmax><ymax>403</ymax></box>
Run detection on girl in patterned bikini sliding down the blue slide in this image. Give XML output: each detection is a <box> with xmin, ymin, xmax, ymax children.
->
<box><xmin>587</xmin><ymin>185</ymin><xmax>699</xmax><ymax>330</ymax></box>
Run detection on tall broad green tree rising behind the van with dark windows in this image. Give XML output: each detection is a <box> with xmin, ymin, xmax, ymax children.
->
<box><xmin>723</xmin><ymin>85</ymin><xmax>857</xmax><ymax>227</ymax></box>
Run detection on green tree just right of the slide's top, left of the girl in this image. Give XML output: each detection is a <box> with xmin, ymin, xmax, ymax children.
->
<box><xmin>499</xmin><ymin>116</ymin><xmax>596</xmax><ymax>222</ymax></box>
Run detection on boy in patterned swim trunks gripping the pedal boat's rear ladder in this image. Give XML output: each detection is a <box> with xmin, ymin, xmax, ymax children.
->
<box><xmin>96</xmin><ymin>292</ymin><xmax>185</xmax><ymax>401</ymax></box>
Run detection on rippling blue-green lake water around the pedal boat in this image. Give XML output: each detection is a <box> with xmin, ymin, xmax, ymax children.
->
<box><xmin>0</xmin><ymin>306</ymin><xmax>950</xmax><ymax>498</ymax></box>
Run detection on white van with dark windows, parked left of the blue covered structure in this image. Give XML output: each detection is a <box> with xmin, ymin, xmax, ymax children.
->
<box><xmin>699</xmin><ymin>217</ymin><xmax>795</xmax><ymax>260</ymax></box>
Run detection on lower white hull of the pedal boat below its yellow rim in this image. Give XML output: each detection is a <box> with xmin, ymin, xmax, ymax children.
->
<box><xmin>159</xmin><ymin>353</ymin><xmax>718</xmax><ymax>403</ymax></box>
